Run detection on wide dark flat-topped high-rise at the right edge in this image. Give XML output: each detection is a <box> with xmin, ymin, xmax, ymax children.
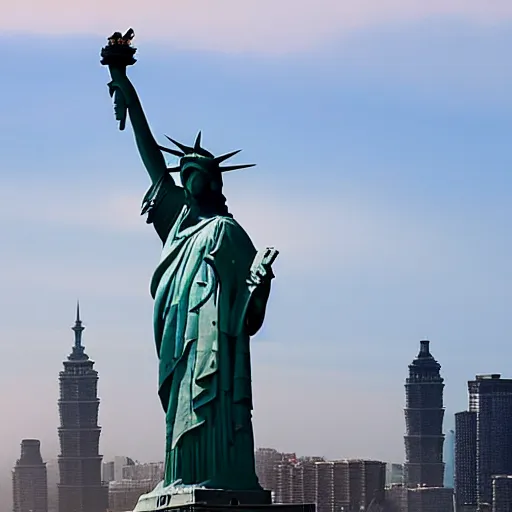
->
<box><xmin>468</xmin><ymin>374</ymin><xmax>512</xmax><ymax>507</ymax></box>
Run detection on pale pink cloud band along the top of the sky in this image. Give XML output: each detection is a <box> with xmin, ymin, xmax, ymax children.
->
<box><xmin>0</xmin><ymin>0</ymin><xmax>512</xmax><ymax>53</ymax></box>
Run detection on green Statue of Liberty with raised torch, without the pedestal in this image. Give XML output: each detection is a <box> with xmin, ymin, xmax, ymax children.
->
<box><xmin>98</xmin><ymin>30</ymin><xmax>277</xmax><ymax>490</ymax></box>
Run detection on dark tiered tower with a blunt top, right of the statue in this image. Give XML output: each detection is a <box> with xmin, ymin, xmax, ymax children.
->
<box><xmin>404</xmin><ymin>340</ymin><xmax>444</xmax><ymax>488</ymax></box>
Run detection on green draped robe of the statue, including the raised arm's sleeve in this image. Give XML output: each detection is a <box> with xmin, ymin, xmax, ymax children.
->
<box><xmin>143</xmin><ymin>177</ymin><xmax>260</xmax><ymax>489</ymax></box>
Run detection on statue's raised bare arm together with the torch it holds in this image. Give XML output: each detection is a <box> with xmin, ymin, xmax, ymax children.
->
<box><xmin>101</xmin><ymin>30</ymin><xmax>174</xmax><ymax>183</ymax></box>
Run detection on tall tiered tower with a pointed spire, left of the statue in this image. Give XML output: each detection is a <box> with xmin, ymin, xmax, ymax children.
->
<box><xmin>59</xmin><ymin>305</ymin><xmax>108</xmax><ymax>512</ymax></box>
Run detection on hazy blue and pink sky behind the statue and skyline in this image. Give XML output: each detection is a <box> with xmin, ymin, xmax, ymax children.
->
<box><xmin>0</xmin><ymin>0</ymin><xmax>512</xmax><ymax>500</ymax></box>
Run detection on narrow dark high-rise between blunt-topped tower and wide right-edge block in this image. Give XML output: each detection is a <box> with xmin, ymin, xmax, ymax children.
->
<box><xmin>454</xmin><ymin>411</ymin><xmax>477</xmax><ymax>512</ymax></box>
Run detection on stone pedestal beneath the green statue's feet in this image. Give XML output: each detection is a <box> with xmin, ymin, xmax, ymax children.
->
<box><xmin>133</xmin><ymin>483</ymin><xmax>315</xmax><ymax>512</ymax></box>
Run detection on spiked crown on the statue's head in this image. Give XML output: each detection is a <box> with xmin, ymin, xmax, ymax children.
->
<box><xmin>159</xmin><ymin>132</ymin><xmax>255</xmax><ymax>173</ymax></box>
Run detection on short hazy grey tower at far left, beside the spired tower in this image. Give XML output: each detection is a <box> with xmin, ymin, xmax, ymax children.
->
<box><xmin>12</xmin><ymin>439</ymin><xmax>48</xmax><ymax>512</ymax></box>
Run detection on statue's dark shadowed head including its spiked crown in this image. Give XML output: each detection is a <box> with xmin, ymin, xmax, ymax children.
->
<box><xmin>160</xmin><ymin>132</ymin><xmax>254</xmax><ymax>212</ymax></box>
